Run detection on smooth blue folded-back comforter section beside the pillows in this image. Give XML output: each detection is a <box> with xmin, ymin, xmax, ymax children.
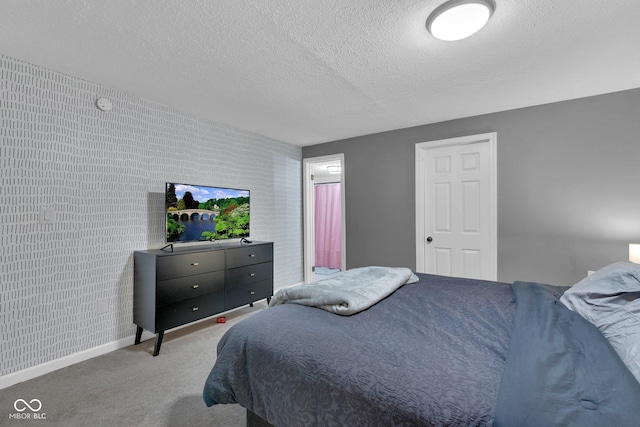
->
<box><xmin>495</xmin><ymin>282</ymin><xmax>640</xmax><ymax>427</ymax></box>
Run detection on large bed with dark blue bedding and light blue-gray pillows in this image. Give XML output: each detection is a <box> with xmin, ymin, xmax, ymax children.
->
<box><xmin>203</xmin><ymin>263</ymin><xmax>640</xmax><ymax>427</ymax></box>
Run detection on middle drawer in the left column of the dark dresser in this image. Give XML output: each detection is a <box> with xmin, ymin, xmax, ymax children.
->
<box><xmin>156</xmin><ymin>270</ymin><xmax>224</xmax><ymax>307</ymax></box>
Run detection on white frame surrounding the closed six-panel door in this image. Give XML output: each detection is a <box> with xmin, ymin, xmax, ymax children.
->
<box><xmin>415</xmin><ymin>132</ymin><xmax>498</xmax><ymax>280</ymax></box>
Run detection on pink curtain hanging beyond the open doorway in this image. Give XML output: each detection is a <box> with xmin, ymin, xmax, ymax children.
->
<box><xmin>315</xmin><ymin>183</ymin><xmax>342</xmax><ymax>269</ymax></box>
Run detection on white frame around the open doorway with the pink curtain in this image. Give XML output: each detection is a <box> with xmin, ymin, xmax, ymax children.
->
<box><xmin>302</xmin><ymin>153</ymin><xmax>347</xmax><ymax>283</ymax></box>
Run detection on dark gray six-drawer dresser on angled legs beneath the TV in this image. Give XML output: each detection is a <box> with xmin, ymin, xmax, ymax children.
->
<box><xmin>133</xmin><ymin>242</ymin><xmax>273</xmax><ymax>356</ymax></box>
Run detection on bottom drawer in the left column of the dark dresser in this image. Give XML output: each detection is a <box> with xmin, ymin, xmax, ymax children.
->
<box><xmin>154</xmin><ymin>292</ymin><xmax>224</xmax><ymax>332</ymax></box>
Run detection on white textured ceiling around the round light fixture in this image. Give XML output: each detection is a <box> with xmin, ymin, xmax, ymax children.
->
<box><xmin>0</xmin><ymin>0</ymin><xmax>640</xmax><ymax>145</ymax></box>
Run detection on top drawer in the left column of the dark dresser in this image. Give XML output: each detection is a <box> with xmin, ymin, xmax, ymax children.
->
<box><xmin>156</xmin><ymin>251</ymin><xmax>224</xmax><ymax>280</ymax></box>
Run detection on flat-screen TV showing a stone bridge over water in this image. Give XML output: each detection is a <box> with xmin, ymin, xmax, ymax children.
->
<box><xmin>165</xmin><ymin>182</ymin><xmax>250</xmax><ymax>243</ymax></box>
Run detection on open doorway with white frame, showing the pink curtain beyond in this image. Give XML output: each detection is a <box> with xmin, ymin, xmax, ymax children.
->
<box><xmin>303</xmin><ymin>153</ymin><xmax>346</xmax><ymax>283</ymax></box>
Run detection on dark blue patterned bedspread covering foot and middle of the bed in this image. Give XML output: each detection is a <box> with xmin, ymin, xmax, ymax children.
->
<box><xmin>204</xmin><ymin>274</ymin><xmax>514</xmax><ymax>427</ymax></box>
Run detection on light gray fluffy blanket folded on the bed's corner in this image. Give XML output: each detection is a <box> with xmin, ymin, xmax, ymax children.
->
<box><xmin>269</xmin><ymin>266</ymin><xmax>419</xmax><ymax>316</ymax></box>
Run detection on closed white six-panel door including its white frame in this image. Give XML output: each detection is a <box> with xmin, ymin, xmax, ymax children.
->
<box><xmin>416</xmin><ymin>133</ymin><xmax>497</xmax><ymax>280</ymax></box>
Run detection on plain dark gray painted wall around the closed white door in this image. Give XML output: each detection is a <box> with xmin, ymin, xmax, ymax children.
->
<box><xmin>302</xmin><ymin>89</ymin><xmax>640</xmax><ymax>285</ymax></box>
